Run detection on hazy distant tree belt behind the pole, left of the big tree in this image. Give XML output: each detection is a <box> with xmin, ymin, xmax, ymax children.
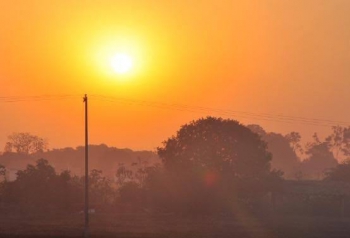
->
<box><xmin>0</xmin><ymin>144</ymin><xmax>159</xmax><ymax>178</ymax></box>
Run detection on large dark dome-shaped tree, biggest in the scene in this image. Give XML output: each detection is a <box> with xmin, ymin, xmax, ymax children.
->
<box><xmin>157</xmin><ymin>117</ymin><xmax>276</xmax><ymax>214</ymax></box>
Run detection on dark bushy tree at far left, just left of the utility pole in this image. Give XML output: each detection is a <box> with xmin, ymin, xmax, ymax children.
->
<box><xmin>1</xmin><ymin>159</ymin><xmax>82</xmax><ymax>212</ymax></box>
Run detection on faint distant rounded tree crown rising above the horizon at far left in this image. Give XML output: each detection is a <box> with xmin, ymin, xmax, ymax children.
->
<box><xmin>4</xmin><ymin>133</ymin><xmax>48</xmax><ymax>154</ymax></box>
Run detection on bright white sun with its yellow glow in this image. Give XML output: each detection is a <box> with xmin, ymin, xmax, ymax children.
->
<box><xmin>87</xmin><ymin>30</ymin><xmax>154</xmax><ymax>85</ymax></box>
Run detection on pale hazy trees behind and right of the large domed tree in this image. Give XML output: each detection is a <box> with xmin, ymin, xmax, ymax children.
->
<box><xmin>247</xmin><ymin>125</ymin><xmax>350</xmax><ymax>180</ymax></box>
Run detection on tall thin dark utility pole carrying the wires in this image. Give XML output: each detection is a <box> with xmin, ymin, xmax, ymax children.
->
<box><xmin>84</xmin><ymin>94</ymin><xmax>89</xmax><ymax>238</ymax></box>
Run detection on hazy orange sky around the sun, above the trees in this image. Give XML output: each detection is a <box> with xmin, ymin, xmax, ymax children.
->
<box><xmin>0</xmin><ymin>0</ymin><xmax>350</xmax><ymax>150</ymax></box>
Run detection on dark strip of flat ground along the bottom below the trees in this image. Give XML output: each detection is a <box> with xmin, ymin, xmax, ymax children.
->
<box><xmin>0</xmin><ymin>213</ymin><xmax>350</xmax><ymax>238</ymax></box>
